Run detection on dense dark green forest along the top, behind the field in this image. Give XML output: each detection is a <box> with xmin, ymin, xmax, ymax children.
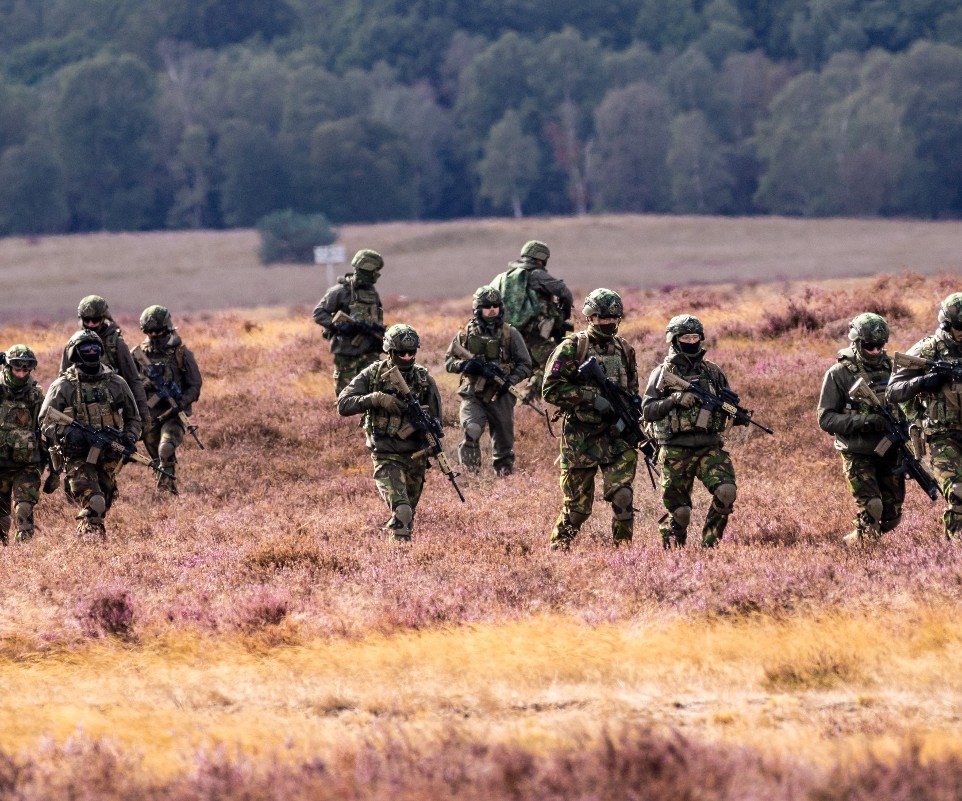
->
<box><xmin>0</xmin><ymin>0</ymin><xmax>962</xmax><ymax>236</ymax></box>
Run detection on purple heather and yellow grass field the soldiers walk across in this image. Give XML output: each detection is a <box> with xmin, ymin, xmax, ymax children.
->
<box><xmin>0</xmin><ymin>272</ymin><xmax>962</xmax><ymax>801</ymax></box>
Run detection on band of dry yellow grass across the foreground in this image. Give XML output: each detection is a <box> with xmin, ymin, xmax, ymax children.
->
<box><xmin>0</xmin><ymin>607</ymin><xmax>962</xmax><ymax>775</ymax></box>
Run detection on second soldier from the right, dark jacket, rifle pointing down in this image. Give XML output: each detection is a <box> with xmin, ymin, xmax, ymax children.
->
<box><xmin>818</xmin><ymin>312</ymin><xmax>905</xmax><ymax>545</ymax></box>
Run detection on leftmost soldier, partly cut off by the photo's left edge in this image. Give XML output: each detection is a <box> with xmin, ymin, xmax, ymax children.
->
<box><xmin>0</xmin><ymin>345</ymin><xmax>44</xmax><ymax>545</ymax></box>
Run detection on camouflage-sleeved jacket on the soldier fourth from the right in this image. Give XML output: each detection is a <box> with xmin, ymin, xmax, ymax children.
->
<box><xmin>541</xmin><ymin>331</ymin><xmax>638</xmax><ymax>468</ymax></box>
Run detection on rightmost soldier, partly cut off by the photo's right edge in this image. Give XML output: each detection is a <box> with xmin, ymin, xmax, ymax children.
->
<box><xmin>886</xmin><ymin>292</ymin><xmax>962</xmax><ymax>539</ymax></box>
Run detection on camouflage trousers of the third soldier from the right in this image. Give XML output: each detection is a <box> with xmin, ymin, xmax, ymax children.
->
<box><xmin>658</xmin><ymin>445</ymin><xmax>735</xmax><ymax>547</ymax></box>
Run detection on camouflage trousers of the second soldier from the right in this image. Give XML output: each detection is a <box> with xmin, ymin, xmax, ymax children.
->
<box><xmin>841</xmin><ymin>448</ymin><xmax>905</xmax><ymax>539</ymax></box>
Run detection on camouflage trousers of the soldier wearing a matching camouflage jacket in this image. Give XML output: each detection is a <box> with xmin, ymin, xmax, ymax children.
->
<box><xmin>551</xmin><ymin>449</ymin><xmax>638</xmax><ymax>548</ymax></box>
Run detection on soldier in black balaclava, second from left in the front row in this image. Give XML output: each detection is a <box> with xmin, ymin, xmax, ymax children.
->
<box><xmin>40</xmin><ymin>330</ymin><xmax>141</xmax><ymax>539</ymax></box>
